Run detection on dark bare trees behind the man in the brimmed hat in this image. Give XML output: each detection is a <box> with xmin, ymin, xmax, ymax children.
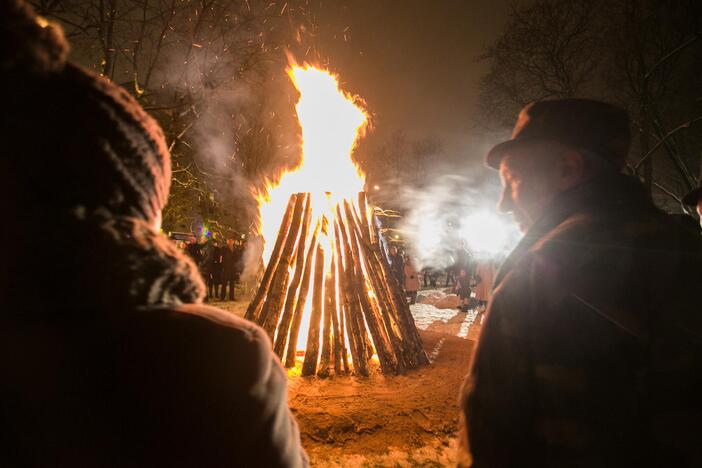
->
<box><xmin>480</xmin><ymin>0</ymin><xmax>702</xmax><ymax>212</ymax></box>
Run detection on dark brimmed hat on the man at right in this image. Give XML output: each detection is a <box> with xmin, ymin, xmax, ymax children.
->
<box><xmin>485</xmin><ymin>99</ymin><xmax>631</xmax><ymax>169</ymax></box>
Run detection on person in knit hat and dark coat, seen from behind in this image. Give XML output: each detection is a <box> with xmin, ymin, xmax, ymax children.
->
<box><xmin>0</xmin><ymin>0</ymin><xmax>307</xmax><ymax>466</ymax></box>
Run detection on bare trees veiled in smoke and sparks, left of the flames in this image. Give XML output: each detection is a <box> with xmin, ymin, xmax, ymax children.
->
<box><xmin>35</xmin><ymin>0</ymin><xmax>304</xmax><ymax>234</ymax></box>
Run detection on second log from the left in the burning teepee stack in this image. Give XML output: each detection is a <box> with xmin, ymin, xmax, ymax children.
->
<box><xmin>257</xmin><ymin>193</ymin><xmax>307</xmax><ymax>343</ymax></box>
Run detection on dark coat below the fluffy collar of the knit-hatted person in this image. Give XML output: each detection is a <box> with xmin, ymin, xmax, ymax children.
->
<box><xmin>0</xmin><ymin>305</ymin><xmax>305</xmax><ymax>467</ymax></box>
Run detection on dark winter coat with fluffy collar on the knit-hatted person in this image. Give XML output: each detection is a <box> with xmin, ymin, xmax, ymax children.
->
<box><xmin>0</xmin><ymin>216</ymin><xmax>307</xmax><ymax>467</ymax></box>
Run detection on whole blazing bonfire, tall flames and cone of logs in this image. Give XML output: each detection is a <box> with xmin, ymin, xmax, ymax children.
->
<box><xmin>246</xmin><ymin>65</ymin><xmax>428</xmax><ymax>377</ymax></box>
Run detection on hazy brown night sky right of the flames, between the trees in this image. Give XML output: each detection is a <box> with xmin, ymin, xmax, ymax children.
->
<box><xmin>316</xmin><ymin>0</ymin><xmax>511</xmax><ymax>163</ymax></box>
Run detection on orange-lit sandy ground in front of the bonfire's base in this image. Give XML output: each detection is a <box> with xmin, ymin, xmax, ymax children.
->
<box><xmin>213</xmin><ymin>292</ymin><xmax>480</xmax><ymax>467</ymax></box>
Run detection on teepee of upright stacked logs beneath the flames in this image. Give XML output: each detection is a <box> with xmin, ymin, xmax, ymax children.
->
<box><xmin>246</xmin><ymin>192</ymin><xmax>429</xmax><ymax>377</ymax></box>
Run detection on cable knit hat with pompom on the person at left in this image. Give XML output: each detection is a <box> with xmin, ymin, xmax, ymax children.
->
<box><xmin>0</xmin><ymin>0</ymin><xmax>171</xmax><ymax>221</ymax></box>
